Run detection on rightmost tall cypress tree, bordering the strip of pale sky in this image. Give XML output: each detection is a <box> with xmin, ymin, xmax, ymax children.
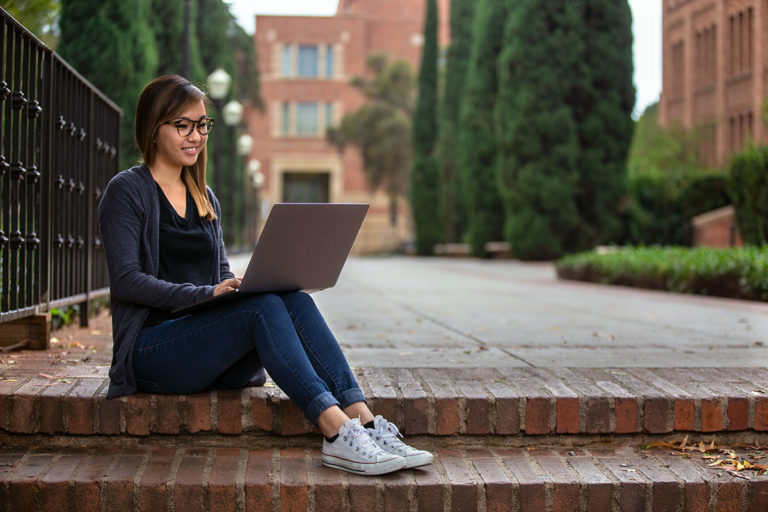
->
<box><xmin>572</xmin><ymin>0</ymin><xmax>635</xmax><ymax>249</ymax></box>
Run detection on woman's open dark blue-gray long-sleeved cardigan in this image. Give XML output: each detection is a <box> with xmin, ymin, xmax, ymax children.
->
<box><xmin>99</xmin><ymin>164</ymin><xmax>234</xmax><ymax>398</ymax></box>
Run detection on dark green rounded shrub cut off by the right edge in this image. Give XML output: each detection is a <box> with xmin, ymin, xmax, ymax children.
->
<box><xmin>729</xmin><ymin>145</ymin><xmax>768</xmax><ymax>245</ymax></box>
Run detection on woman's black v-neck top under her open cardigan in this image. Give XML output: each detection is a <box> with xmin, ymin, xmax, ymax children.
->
<box><xmin>144</xmin><ymin>185</ymin><xmax>216</xmax><ymax>327</ymax></box>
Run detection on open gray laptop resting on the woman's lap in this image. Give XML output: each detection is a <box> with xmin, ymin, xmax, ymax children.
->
<box><xmin>172</xmin><ymin>203</ymin><xmax>368</xmax><ymax>316</ymax></box>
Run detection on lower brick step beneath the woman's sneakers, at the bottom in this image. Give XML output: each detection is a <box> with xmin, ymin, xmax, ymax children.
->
<box><xmin>0</xmin><ymin>446</ymin><xmax>768</xmax><ymax>512</ymax></box>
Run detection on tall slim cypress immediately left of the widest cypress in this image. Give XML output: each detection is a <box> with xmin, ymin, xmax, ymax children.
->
<box><xmin>457</xmin><ymin>0</ymin><xmax>508</xmax><ymax>256</ymax></box>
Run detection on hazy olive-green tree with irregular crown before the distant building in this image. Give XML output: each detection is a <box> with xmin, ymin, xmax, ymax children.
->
<box><xmin>327</xmin><ymin>53</ymin><xmax>414</xmax><ymax>225</ymax></box>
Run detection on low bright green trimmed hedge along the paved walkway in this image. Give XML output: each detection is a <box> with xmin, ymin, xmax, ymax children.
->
<box><xmin>555</xmin><ymin>245</ymin><xmax>768</xmax><ymax>301</ymax></box>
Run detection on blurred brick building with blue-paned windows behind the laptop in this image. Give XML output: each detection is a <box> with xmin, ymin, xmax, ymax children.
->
<box><xmin>246</xmin><ymin>0</ymin><xmax>448</xmax><ymax>252</ymax></box>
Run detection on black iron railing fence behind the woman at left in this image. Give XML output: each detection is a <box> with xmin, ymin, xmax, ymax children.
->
<box><xmin>0</xmin><ymin>8</ymin><xmax>122</xmax><ymax>324</ymax></box>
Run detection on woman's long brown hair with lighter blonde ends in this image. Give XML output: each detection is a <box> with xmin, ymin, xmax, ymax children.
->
<box><xmin>134</xmin><ymin>75</ymin><xmax>216</xmax><ymax>220</ymax></box>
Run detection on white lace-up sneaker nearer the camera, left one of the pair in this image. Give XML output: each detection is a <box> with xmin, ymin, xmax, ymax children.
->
<box><xmin>322</xmin><ymin>418</ymin><xmax>406</xmax><ymax>475</ymax></box>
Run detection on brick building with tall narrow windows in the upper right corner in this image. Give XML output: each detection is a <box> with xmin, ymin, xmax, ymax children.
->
<box><xmin>659</xmin><ymin>0</ymin><xmax>768</xmax><ymax>165</ymax></box>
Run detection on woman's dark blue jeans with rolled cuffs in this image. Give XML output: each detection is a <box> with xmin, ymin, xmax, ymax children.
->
<box><xmin>133</xmin><ymin>292</ymin><xmax>365</xmax><ymax>425</ymax></box>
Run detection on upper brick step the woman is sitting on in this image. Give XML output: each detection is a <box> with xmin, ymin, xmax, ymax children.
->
<box><xmin>0</xmin><ymin>368</ymin><xmax>768</xmax><ymax>436</ymax></box>
